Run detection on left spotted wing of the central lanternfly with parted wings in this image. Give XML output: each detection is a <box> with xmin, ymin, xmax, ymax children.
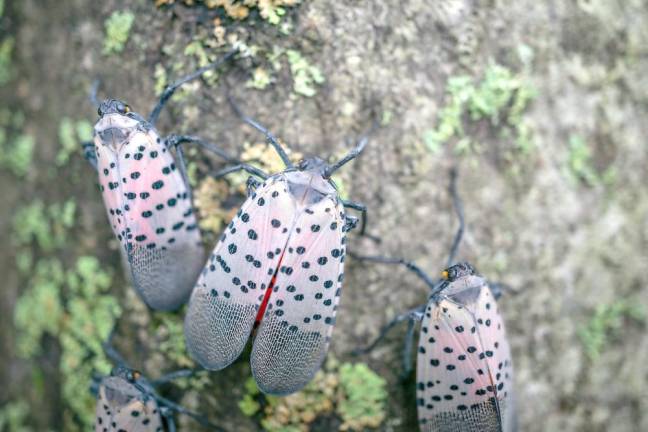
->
<box><xmin>185</xmin><ymin>176</ymin><xmax>295</xmax><ymax>370</ymax></box>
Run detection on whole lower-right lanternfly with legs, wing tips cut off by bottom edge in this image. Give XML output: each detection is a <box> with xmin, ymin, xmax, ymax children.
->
<box><xmin>352</xmin><ymin>169</ymin><xmax>515</xmax><ymax>432</ymax></box>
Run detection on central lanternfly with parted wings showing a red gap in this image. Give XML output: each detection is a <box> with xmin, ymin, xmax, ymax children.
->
<box><xmin>185</xmin><ymin>99</ymin><xmax>367</xmax><ymax>395</ymax></box>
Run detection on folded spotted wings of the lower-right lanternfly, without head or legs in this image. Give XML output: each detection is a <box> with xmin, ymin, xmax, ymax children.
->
<box><xmin>417</xmin><ymin>278</ymin><xmax>514</xmax><ymax>432</ymax></box>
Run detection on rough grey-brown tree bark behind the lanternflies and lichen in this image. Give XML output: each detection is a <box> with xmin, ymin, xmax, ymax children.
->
<box><xmin>0</xmin><ymin>0</ymin><xmax>648</xmax><ymax>431</ymax></box>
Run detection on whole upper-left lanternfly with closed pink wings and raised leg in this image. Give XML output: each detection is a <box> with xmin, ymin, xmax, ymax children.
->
<box><xmin>86</xmin><ymin>52</ymin><xmax>234</xmax><ymax>310</ymax></box>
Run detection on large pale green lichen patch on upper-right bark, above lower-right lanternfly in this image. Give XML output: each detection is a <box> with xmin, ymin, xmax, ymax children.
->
<box><xmin>422</xmin><ymin>64</ymin><xmax>536</xmax><ymax>158</ymax></box>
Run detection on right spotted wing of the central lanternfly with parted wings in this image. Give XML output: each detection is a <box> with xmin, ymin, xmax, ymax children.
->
<box><xmin>251</xmin><ymin>196</ymin><xmax>345</xmax><ymax>395</ymax></box>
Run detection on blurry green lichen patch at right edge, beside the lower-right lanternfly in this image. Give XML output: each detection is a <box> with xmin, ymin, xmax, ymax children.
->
<box><xmin>578</xmin><ymin>300</ymin><xmax>646</xmax><ymax>361</ymax></box>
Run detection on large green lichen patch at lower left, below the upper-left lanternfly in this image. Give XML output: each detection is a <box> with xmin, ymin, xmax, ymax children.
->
<box><xmin>14</xmin><ymin>256</ymin><xmax>121</xmax><ymax>430</ymax></box>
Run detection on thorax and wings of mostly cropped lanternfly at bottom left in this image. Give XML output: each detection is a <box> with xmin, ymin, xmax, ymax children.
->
<box><xmin>95</xmin><ymin>377</ymin><xmax>163</xmax><ymax>432</ymax></box>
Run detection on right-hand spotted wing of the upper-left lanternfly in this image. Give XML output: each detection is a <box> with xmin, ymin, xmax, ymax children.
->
<box><xmin>118</xmin><ymin>130</ymin><xmax>205</xmax><ymax>310</ymax></box>
